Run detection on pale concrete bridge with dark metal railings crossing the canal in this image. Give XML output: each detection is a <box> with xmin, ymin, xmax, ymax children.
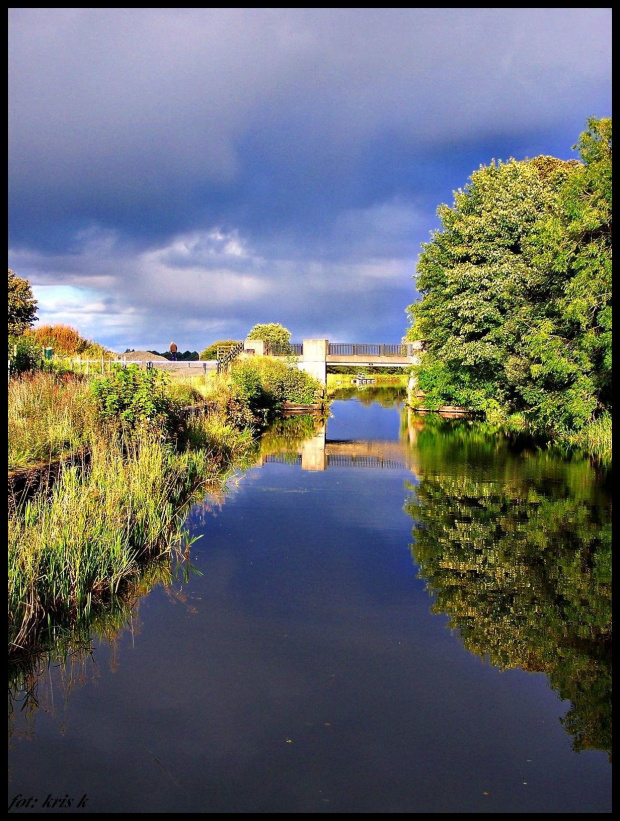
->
<box><xmin>235</xmin><ymin>339</ymin><xmax>422</xmax><ymax>385</ymax></box>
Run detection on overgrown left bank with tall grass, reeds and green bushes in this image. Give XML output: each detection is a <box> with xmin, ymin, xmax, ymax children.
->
<box><xmin>8</xmin><ymin>363</ymin><xmax>324</xmax><ymax>655</ymax></box>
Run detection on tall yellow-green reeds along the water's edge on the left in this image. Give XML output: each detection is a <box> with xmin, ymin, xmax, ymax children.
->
<box><xmin>8</xmin><ymin>419</ymin><xmax>252</xmax><ymax>653</ymax></box>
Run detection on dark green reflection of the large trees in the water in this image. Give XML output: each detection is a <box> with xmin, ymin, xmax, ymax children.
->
<box><xmin>405</xmin><ymin>417</ymin><xmax>611</xmax><ymax>760</ymax></box>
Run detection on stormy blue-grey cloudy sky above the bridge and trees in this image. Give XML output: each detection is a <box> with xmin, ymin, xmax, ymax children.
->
<box><xmin>8</xmin><ymin>8</ymin><xmax>611</xmax><ymax>352</ymax></box>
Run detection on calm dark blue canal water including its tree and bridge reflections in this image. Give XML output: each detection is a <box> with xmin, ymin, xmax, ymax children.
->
<box><xmin>8</xmin><ymin>392</ymin><xmax>611</xmax><ymax>813</ymax></box>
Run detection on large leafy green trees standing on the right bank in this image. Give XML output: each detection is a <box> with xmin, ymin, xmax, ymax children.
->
<box><xmin>407</xmin><ymin>119</ymin><xmax>611</xmax><ymax>433</ymax></box>
